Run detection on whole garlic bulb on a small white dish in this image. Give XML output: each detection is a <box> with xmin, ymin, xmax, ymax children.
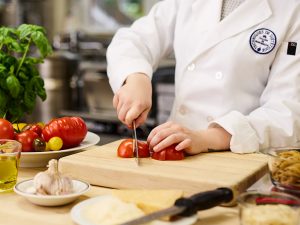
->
<box><xmin>33</xmin><ymin>159</ymin><xmax>73</xmax><ymax>195</ymax></box>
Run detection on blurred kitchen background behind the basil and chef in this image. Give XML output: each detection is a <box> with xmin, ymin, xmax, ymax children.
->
<box><xmin>0</xmin><ymin>0</ymin><xmax>175</xmax><ymax>144</ymax></box>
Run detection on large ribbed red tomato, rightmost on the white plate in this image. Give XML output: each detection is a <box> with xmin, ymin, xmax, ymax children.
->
<box><xmin>42</xmin><ymin>116</ymin><xmax>87</xmax><ymax>149</ymax></box>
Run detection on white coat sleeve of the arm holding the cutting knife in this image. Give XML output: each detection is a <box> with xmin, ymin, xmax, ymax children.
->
<box><xmin>106</xmin><ymin>0</ymin><xmax>178</xmax><ymax>92</ymax></box>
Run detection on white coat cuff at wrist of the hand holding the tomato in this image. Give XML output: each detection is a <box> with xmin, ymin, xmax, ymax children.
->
<box><xmin>209</xmin><ymin>111</ymin><xmax>259</xmax><ymax>153</ymax></box>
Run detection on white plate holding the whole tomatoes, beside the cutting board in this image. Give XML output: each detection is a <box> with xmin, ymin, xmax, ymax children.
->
<box><xmin>20</xmin><ymin>132</ymin><xmax>100</xmax><ymax>167</ymax></box>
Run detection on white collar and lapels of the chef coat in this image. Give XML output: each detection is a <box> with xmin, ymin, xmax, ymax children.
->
<box><xmin>185</xmin><ymin>0</ymin><xmax>272</xmax><ymax>66</ymax></box>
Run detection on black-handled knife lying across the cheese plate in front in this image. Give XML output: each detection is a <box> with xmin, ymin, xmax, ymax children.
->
<box><xmin>121</xmin><ymin>188</ymin><xmax>233</xmax><ymax>225</ymax></box>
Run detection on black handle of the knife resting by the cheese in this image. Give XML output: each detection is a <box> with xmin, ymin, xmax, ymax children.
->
<box><xmin>175</xmin><ymin>188</ymin><xmax>233</xmax><ymax>217</ymax></box>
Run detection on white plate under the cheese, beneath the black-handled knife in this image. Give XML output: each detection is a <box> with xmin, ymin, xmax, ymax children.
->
<box><xmin>71</xmin><ymin>195</ymin><xmax>198</xmax><ymax>225</ymax></box>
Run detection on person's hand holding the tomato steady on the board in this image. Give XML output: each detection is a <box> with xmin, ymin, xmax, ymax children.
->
<box><xmin>147</xmin><ymin>121</ymin><xmax>231</xmax><ymax>155</ymax></box>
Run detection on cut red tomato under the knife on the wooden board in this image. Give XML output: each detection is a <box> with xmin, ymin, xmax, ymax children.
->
<box><xmin>118</xmin><ymin>139</ymin><xmax>184</xmax><ymax>160</ymax></box>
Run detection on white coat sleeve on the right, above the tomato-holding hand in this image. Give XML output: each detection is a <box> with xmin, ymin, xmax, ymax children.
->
<box><xmin>210</xmin><ymin>8</ymin><xmax>300</xmax><ymax>153</ymax></box>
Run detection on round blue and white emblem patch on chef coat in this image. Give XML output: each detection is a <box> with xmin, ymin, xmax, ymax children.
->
<box><xmin>250</xmin><ymin>28</ymin><xmax>277</xmax><ymax>54</ymax></box>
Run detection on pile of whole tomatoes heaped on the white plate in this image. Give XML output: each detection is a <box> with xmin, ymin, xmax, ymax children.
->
<box><xmin>0</xmin><ymin>117</ymin><xmax>87</xmax><ymax>152</ymax></box>
